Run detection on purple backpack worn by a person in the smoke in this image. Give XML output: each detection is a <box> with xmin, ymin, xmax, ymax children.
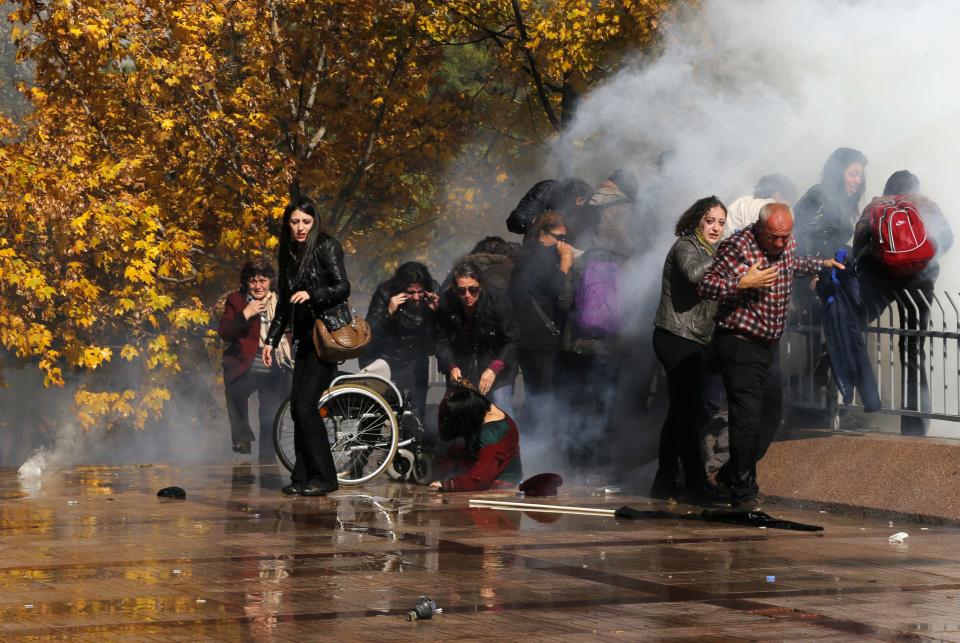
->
<box><xmin>574</xmin><ymin>258</ymin><xmax>621</xmax><ymax>338</ymax></box>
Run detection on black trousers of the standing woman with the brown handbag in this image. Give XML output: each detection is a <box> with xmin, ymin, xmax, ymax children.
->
<box><xmin>290</xmin><ymin>338</ymin><xmax>339</xmax><ymax>491</ymax></box>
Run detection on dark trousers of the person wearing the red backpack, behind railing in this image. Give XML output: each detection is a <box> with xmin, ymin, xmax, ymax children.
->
<box><xmin>857</xmin><ymin>257</ymin><xmax>934</xmax><ymax>435</ymax></box>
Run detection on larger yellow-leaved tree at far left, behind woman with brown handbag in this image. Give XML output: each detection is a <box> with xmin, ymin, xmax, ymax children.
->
<box><xmin>0</xmin><ymin>0</ymin><xmax>476</xmax><ymax>432</ymax></box>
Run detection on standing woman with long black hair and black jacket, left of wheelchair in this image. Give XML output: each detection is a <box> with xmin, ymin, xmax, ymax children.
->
<box><xmin>263</xmin><ymin>197</ymin><xmax>350</xmax><ymax>496</ymax></box>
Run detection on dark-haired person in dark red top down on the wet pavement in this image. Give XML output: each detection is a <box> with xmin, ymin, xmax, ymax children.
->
<box><xmin>430</xmin><ymin>386</ymin><xmax>523</xmax><ymax>492</ymax></box>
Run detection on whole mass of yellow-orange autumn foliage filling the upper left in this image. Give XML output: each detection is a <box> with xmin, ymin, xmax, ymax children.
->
<box><xmin>0</xmin><ymin>0</ymin><xmax>668</xmax><ymax>426</ymax></box>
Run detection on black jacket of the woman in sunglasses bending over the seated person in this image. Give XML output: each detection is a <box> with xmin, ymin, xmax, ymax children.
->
<box><xmin>436</xmin><ymin>288</ymin><xmax>517</xmax><ymax>389</ymax></box>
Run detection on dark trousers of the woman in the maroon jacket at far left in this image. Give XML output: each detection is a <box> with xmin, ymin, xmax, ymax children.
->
<box><xmin>225</xmin><ymin>364</ymin><xmax>290</xmax><ymax>460</ymax></box>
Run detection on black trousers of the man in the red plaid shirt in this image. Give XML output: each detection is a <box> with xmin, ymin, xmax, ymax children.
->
<box><xmin>713</xmin><ymin>330</ymin><xmax>783</xmax><ymax>502</ymax></box>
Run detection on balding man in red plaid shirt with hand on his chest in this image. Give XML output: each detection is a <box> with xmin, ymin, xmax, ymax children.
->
<box><xmin>697</xmin><ymin>203</ymin><xmax>843</xmax><ymax>510</ymax></box>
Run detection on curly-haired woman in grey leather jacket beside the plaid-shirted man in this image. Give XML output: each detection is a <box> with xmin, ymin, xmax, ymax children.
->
<box><xmin>650</xmin><ymin>196</ymin><xmax>727</xmax><ymax>500</ymax></box>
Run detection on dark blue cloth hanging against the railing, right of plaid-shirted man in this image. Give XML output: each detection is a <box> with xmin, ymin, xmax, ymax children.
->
<box><xmin>817</xmin><ymin>248</ymin><xmax>880</xmax><ymax>412</ymax></box>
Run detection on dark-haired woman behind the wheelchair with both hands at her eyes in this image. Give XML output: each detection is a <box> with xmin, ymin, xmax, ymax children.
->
<box><xmin>360</xmin><ymin>261</ymin><xmax>440</xmax><ymax>420</ymax></box>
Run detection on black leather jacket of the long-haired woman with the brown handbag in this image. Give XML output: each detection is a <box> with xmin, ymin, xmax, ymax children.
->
<box><xmin>267</xmin><ymin>232</ymin><xmax>350</xmax><ymax>348</ymax></box>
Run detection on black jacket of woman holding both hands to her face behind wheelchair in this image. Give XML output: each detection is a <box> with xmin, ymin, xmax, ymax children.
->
<box><xmin>360</xmin><ymin>279</ymin><xmax>439</xmax><ymax>367</ymax></box>
